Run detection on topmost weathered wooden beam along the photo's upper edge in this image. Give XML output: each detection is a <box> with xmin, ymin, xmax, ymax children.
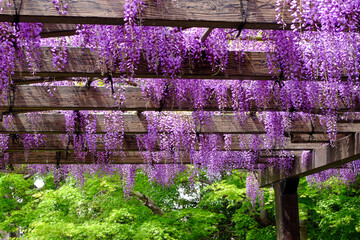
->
<box><xmin>0</xmin><ymin>0</ymin><xmax>291</xmax><ymax>29</ymax></box>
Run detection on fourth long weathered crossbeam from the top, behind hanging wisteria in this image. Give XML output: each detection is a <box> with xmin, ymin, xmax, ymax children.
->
<box><xmin>0</xmin><ymin>113</ymin><xmax>360</xmax><ymax>134</ymax></box>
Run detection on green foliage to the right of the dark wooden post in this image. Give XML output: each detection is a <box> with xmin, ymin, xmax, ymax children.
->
<box><xmin>299</xmin><ymin>178</ymin><xmax>360</xmax><ymax>239</ymax></box>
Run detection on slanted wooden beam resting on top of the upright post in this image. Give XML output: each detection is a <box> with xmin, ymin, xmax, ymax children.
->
<box><xmin>259</xmin><ymin>132</ymin><xmax>360</xmax><ymax>187</ymax></box>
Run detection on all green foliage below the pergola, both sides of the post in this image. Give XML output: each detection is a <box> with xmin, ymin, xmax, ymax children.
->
<box><xmin>0</xmin><ymin>172</ymin><xmax>360</xmax><ymax>240</ymax></box>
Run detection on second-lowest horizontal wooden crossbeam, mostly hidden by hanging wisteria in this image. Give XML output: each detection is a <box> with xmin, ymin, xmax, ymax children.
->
<box><xmin>6</xmin><ymin>134</ymin><xmax>319</xmax><ymax>152</ymax></box>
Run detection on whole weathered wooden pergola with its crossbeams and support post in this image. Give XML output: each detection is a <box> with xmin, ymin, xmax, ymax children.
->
<box><xmin>0</xmin><ymin>0</ymin><xmax>360</xmax><ymax>239</ymax></box>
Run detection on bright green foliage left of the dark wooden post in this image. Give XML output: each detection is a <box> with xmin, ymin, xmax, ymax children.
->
<box><xmin>1</xmin><ymin>170</ymin><xmax>276</xmax><ymax>239</ymax></box>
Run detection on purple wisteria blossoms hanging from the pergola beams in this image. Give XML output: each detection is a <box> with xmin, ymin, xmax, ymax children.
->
<box><xmin>0</xmin><ymin>0</ymin><xmax>360</xmax><ymax>202</ymax></box>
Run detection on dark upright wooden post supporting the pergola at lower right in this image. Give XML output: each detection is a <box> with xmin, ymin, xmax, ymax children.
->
<box><xmin>273</xmin><ymin>178</ymin><xmax>300</xmax><ymax>240</ymax></box>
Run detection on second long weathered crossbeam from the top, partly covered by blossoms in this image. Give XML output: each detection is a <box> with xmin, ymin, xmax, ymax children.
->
<box><xmin>15</xmin><ymin>47</ymin><xmax>272</xmax><ymax>80</ymax></box>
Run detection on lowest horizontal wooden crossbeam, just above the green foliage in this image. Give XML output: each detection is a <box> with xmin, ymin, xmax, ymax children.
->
<box><xmin>7</xmin><ymin>151</ymin><xmax>299</xmax><ymax>164</ymax></box>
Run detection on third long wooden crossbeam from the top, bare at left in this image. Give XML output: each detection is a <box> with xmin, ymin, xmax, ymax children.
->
<box><xmin>0</xmin><ymin>85</ymin><xmax>360</xmax><ymax>113</ymax></box>
